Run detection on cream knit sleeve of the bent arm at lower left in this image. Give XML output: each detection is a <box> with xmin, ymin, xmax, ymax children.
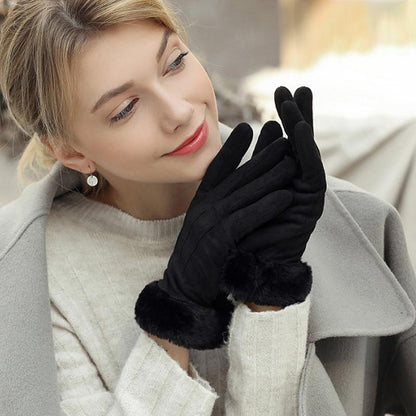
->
<box><xmin>51</xmin><ymin>303</ymin><xmax>218</xmax><ymax>416</ymax></box>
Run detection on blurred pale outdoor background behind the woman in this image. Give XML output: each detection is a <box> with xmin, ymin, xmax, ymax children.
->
<box><xmin>0</xmin><ymin>0</ymin><xmax>416</xmax><ymax>265</ymax></box>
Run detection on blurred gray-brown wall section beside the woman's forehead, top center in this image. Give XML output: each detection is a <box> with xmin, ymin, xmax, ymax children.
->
<box><xmin>168</xmin><ymin>0</ymin><xmax>279</xmax><ymax>83</ymax></box>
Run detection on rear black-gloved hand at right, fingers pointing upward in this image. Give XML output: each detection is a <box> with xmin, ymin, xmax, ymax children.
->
<box><xmin>221</xmin><ymin>87</ymin><xmax>326</xmax><ymax>307</ymax></box>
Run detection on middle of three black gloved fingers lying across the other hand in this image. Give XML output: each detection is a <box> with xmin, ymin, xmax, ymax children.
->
<box><xmin>220</xmin><ymin>156</ymin><xmax>296</xmax><ymax>214</ymax></box>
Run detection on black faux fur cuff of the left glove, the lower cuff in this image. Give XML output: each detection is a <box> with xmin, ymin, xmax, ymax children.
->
<box><xmin>135</xmin><ymin>281</ymin><xmax>234</xmax><ymax>350</ymax></box>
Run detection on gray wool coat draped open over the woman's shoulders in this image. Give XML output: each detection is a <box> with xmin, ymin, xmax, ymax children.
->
<box><xmin>0</xmin><ymin>125</ymin><xmax>416</xmax><ymax>416</ymax></box>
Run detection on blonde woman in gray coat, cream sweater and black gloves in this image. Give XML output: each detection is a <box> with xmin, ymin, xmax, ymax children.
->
<box><xmin>0</xmin><ymin>0</ymin><xmax>415</xmax><ymax>415</ymax></box>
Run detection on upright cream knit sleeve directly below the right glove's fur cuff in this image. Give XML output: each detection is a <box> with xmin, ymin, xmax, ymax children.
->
<box><xmin>225</xmin><ymin>295</ymin><xmax>310</xmax><ymax>416</ymax></box>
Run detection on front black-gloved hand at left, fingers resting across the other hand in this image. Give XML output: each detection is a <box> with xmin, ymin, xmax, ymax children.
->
<box><xmin>135</xmin><ymin>123</ymin><xmax>295</xmax><ymax>349</ymax></box>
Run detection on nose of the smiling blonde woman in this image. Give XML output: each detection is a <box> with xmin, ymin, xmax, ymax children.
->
<box><xmin>156</xmin><ymin>91</ymin><xmax>195</xmax><ymax>133</ymax></box>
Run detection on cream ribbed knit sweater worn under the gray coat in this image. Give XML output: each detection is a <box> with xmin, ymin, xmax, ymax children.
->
<box><xmin>46</xmin><ymin>192</ymin><xmax>310</xmax><ymax>416</ymax></box>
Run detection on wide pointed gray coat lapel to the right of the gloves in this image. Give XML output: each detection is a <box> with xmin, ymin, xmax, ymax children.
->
<box><xmin>220</xmin><ymin>123</ymin><xmax>415</xmax><ymax>342</ymax></box>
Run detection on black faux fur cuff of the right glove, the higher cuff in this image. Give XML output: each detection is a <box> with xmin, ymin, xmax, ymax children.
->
<box><xmin>221</xmin><ymin>250</ymin><xmax>312</xmax><ymax>307</ymax></box>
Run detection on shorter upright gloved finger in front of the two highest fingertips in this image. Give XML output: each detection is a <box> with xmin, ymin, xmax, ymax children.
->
<box><xmin>294</xmin><ymin>121</ymin><xmax>326</xmax><ymax>191</ymax></box>
